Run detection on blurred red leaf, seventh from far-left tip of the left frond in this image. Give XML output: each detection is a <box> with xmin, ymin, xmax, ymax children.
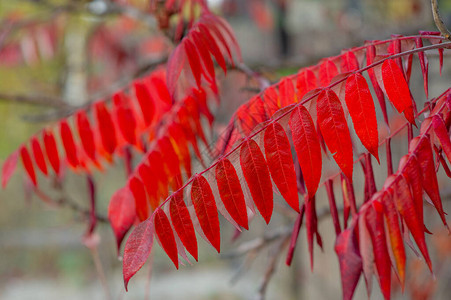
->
<box><xmin>94</xmin><ymin>101</ymin><xmax>117</xmax><ymax>156</ymax></box>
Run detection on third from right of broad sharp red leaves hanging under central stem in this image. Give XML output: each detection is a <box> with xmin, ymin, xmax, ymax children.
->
<box><xmin>316</xmin><ymin>89</ymin><xmax>354</xmax><ymax>181</ymax></box>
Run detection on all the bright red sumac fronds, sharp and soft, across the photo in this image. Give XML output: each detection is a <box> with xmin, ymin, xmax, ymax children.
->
<box><xmin>2</xmin><ymin>1</ymin><xmax>451</xmax><ymax>299</ymax></box>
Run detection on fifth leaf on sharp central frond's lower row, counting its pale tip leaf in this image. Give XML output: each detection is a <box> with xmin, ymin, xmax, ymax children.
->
<box><xmin>215</xmin><ymin>158</ymin><xmax>249</xmax><ymax>230</ymax></box>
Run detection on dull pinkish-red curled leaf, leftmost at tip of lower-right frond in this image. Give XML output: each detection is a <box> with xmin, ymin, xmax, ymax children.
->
<box><xmin>335</xmin><ymin>219</ymin><xmax>362</xmax><ymax>300</ymax></box>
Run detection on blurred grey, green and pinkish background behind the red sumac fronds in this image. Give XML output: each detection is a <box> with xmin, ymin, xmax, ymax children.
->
<box><xmin>0</xmin><ymin>0</ymin><xmax>451</xmax><ymax>300</ymax></box>
